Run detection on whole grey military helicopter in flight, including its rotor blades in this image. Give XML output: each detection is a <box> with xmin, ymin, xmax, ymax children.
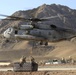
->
<box><xmin>0</xmin><ymin>15</ymin><xmax>76</xmax><ymax>45</ymax></box>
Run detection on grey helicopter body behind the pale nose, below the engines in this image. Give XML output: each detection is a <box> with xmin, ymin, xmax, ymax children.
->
<box><xmin>14</xmin><ymin>29</ymin><xmax>76</xmax><ymax>42</ymax></box>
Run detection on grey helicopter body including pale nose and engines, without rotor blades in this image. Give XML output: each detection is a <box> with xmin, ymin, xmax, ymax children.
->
<box><xmin>4</xmin><ymin>25</ymin><xmax>76</xmax><ymax>45</ymax></box>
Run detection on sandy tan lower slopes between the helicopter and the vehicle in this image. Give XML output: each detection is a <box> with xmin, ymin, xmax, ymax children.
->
<box><xmin>0</xmin><ymin>40</ymin><xmax>76</xmax><ymax>60</ymax></box>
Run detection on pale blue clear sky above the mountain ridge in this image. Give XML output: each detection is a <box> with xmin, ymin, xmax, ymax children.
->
<box><xmin>0</xmin><ymin>0</ymin><xmax>76</xmax><ymax>15</ymax></box>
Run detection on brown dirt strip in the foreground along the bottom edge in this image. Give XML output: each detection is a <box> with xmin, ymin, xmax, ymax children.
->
<box><xmin>0</xmin><ymin>70</ymin><xmax>76</xmax><ymax>75</ymax></box>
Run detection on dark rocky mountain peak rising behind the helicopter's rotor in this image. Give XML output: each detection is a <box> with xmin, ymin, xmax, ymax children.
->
<box><xmin>0</xmin><ymin>4</ymin><xmax>76</xmax><ymax>33</ymax></box>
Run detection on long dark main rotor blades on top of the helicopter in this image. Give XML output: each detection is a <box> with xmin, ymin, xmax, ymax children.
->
<box><xmin>0</xmin><ymin>14</ymin><xmax>58</xmax><ymax>22</ymax></box>
